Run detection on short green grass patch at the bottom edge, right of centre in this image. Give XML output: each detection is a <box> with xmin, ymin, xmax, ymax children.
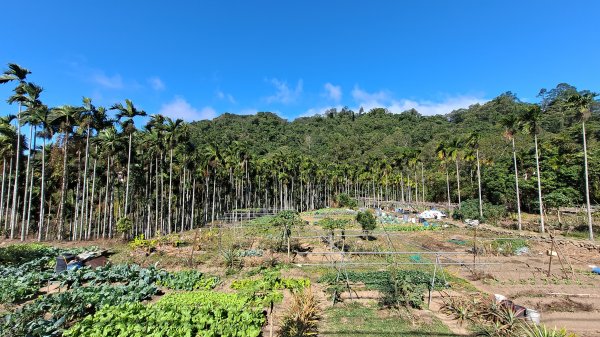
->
<box><xmin>319</xmin><ymin>303</ymin><xmax>456</xmax><ymax>337</ymax></box>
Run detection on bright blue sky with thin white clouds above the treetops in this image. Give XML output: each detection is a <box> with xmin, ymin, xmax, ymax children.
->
<box><xmin>0</xmin><ymin>0</ymin><xmax>600</xmax><ymax>121</ymax></box>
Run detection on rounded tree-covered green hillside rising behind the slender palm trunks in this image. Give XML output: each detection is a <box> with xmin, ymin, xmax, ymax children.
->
<box><xmin>190</xmin><ymin>84</ymin><xmax>600</xmax><ymax>211</ymax></box>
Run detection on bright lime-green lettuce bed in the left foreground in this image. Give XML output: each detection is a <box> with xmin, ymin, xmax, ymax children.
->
<box><xmin>63</xmin><ymin>291</ymin><xmax>265</xmax><ymax>337</ymax></box>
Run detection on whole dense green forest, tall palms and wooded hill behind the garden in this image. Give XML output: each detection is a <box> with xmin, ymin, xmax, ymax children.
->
<box><xmin>0</xmin><ymin>64</ymin><xmax>600</xmax><ymax>240</ymax></box>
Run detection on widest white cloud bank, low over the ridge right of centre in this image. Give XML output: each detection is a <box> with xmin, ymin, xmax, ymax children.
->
<box><xmin>352</xmin><ymin>86</ymin><xmax>486</xmax><ymax>116</ymax></box>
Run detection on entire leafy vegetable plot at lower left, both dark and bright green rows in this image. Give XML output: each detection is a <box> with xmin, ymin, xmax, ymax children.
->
<box><xmin>0</xmin><ymin>245</ymin><xmax>310</xmax><ymax>337</ymax></box>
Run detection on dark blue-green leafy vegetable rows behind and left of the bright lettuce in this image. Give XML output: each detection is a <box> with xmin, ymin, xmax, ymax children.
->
<box><xmin>0</xmin><ymin>244</ymin><xmax>219</xmax><ymax>337</ymax></box>
